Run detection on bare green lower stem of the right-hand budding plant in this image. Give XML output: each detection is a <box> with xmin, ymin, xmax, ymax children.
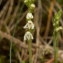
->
<box><xmin>53</xmin><ymin>32</ymin><xmax>59</xmax><ymax>63</ymax></box>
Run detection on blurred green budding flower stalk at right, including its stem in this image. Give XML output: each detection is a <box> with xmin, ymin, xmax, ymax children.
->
<box><xmin>53</xmin><ymin>10</ymin><xmax>62</xmax><ymax>63</ymax></box>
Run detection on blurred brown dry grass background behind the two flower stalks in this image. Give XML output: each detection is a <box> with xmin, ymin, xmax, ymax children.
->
<box><xmin>0</xmin><ymin>0</ymin><xmax>63</xmax><ymax>63</ymax></box>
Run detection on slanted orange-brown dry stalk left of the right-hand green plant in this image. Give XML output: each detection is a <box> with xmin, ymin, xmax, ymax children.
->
<box><xmin>44</xmin><ymin>0</ymin><xmax>55</xmax><ymax>37</ymax></box>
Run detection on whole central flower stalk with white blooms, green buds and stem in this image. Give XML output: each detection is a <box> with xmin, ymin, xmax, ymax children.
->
<box><xmin>23</xmin><ymin>0</ymin><xmax>35</xmax><ymax>63</ymax></box>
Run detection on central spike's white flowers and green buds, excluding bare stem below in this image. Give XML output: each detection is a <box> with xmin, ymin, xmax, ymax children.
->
<box><xmin>23</xmin><ymin>0</ymin><xmax>35</xmax><ymax>41</ymax></box>
